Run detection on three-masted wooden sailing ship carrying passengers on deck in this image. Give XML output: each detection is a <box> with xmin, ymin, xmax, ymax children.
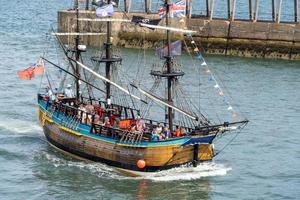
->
<box><xmin>38</xmin><ymin>0</ymin><xmax>248</xmax><ymax>173</ymax></box>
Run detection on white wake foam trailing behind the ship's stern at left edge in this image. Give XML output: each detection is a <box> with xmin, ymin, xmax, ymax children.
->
<box><xmin>0</xmin><ymin>118</ymin><xmax>42</xmax><ymax>134</ymax></box>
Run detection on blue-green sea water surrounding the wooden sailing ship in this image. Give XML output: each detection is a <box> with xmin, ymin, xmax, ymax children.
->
<box><xmin>0</xmin><ymin>0</ymin><xmax>300</xmax><ymax>199</ymax></box>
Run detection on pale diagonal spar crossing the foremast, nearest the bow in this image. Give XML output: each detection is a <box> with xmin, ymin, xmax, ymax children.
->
<box><xmin>130</xmin><ymin>83</ymin><xmax>198</xmax><ymax>121</ymax></box>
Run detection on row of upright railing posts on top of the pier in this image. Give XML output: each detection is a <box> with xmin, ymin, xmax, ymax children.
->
<box><xmin>73</xmin><ymin>0</ymin><xmax>299</xmax><ymax>23</ymax></box>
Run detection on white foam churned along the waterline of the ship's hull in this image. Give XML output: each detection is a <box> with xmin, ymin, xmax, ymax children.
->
<box><xmin>38</xmin><ymin>152</ymin><xmax>231</xmax><ymax>181</ymax></box>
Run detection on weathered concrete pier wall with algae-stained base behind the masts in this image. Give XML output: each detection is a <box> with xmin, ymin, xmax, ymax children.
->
<box><xmin>58</xmin><ymin>10</ymin><xmax>300</xmax><ymax>60</ymax></box>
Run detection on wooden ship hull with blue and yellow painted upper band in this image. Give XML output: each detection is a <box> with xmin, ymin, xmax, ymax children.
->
<box><xmin>38</xmin><ymin>100</ymin><xmax>215</xmax><ymax>172</ymax></box>
